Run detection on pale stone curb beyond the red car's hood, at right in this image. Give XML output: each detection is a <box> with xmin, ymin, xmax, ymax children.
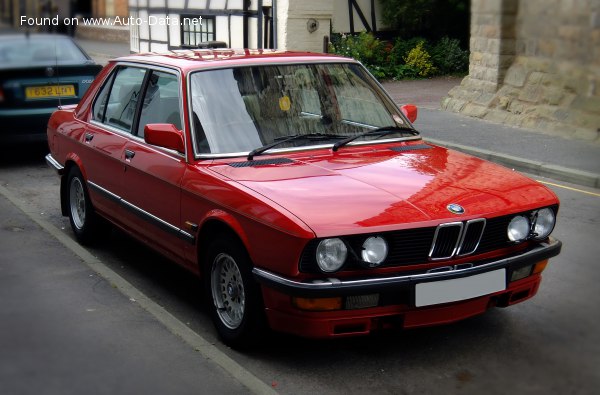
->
<box><xmin>425</xmin><ymin>138</ymin><xmax>600</xmax><ymax>188</ymax></box>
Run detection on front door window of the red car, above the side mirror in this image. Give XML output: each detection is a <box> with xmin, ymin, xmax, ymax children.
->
<box><xmin>137</xmin><ymin>71</ymin><xmax>181</xmax><ymax>137</ymax></box>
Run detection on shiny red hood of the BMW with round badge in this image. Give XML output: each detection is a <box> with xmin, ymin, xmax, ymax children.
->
<box><xmin>211</xmin><ymin>144</ymin><xmax>557</xmax><ymax>237</ymax></box>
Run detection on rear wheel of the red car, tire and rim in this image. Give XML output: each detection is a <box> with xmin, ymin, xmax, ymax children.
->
<box><xmin>65</xmin><ymin>166</ymin><xmax>99</xmax><ymax>244</ymax></box>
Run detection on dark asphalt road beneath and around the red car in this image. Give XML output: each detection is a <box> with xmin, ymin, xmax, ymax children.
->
<box><xmin>0</xmin><ymin>147</ymin><xmax>600</xmax><ymax>394</ymax></box>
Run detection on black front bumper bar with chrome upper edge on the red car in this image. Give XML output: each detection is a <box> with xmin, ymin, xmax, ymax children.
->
<box><xmin>252</xmin><ymin>238</ymin><xmax>562</xmax><ymax>295</ymax></box>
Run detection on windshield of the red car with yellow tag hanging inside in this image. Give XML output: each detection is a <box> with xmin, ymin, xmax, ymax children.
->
<box><xmin>190</xmin><ymin>63</ymin><xmax>408</xmax><ymax>154</ymax></box>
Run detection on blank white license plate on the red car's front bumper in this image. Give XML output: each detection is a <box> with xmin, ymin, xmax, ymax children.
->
<box><xmin>415</xmin><ymin>269</ymin><xmax>506</xmax><ymax>307</ymax></box>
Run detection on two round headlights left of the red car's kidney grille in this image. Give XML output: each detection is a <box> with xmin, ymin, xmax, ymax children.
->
<box><xmin>316</xmin><ymin>236</ymin><xmax>388</xmax><ymax>273</ymax></box>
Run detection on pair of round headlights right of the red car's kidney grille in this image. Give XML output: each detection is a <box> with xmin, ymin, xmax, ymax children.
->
<box><xmin>507</xmin><ymin>208</ymin><xmax>556</xmax><ymax>242</ymax></box>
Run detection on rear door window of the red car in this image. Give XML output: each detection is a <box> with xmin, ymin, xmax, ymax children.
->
<box><xmin>103</xmin><ymin>67</ymin><xmax>146</xmax><ymax>132</ymax></box>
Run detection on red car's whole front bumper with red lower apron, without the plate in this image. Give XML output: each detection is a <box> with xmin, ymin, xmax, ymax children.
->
<box><xmin>254</xmin><ymin>238</ymin><xmax>562</xmax><ymax>338</ymax></box>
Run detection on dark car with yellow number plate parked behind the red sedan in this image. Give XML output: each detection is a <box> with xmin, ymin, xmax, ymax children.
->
<box><xmin>0</xmin><ymin>34</ymin><xmax>102</xmax><ymax>144</ymax></box>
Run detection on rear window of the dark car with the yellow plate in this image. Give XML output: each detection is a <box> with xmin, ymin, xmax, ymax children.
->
<box><xmin>0</xmin><ymin>36</ymin><xmax>89</xmax><ymax>68</ymax></box>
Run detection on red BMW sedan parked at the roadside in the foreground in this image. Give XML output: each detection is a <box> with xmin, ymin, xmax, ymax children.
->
<box><xmin>47</xmin><ymin>50</ymin><xmax>561</xmax><ymax>346</ymax></box>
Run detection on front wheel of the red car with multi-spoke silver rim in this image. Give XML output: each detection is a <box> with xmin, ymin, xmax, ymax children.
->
<box><xmin>204</xmin><ymin>235</ymin><xmax>266</xmax><ymax>349</ymax></box>
